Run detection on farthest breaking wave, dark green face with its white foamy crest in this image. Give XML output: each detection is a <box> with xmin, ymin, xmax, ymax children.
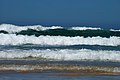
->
<box><xmin>0</xmin><ymin>24</ymin><xmax>120</xmax><ymax>38</ymax></box>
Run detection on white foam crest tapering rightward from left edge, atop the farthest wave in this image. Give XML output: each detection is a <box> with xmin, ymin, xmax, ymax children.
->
<box><xmin>0</xmin><ymin>24</ymin><xmax>63</xmax><ymax>33</ymax></box>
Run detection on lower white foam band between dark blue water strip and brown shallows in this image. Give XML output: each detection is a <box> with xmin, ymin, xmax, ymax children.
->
<box><xmin>0</xmin><ymin>49</ymin><xmax>120</xmax><ymax>61</ymax></box>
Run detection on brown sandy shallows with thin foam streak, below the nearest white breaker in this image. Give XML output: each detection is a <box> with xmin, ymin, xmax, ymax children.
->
<box><xmin>0</xmin><ymin>60</ymin><xmax>120</xmax><ymax>76</ymax></box>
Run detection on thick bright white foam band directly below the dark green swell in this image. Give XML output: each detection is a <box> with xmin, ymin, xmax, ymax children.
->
<box><xmin>0</xmin><ymin>34</ymin><xmax>120</xmax><ymax>46</ymax></box>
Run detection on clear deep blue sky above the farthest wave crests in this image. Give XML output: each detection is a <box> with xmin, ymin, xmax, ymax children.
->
<box><xmin>0</xmin><ymin>0</ymin><xmax>120</xmax><ymax>29</ymax></box>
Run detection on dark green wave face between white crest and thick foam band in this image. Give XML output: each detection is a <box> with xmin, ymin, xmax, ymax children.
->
<box><xmin>16</xmin><ymin>29</ymin><xmax>120</xmax><ymax>38</ymax></box>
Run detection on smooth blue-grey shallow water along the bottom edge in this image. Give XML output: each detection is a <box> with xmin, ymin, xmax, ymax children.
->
<box><xmin>0</xmin><ymin>72</ymin><xmax>120</xmax><ymax>80</ymax></box>
